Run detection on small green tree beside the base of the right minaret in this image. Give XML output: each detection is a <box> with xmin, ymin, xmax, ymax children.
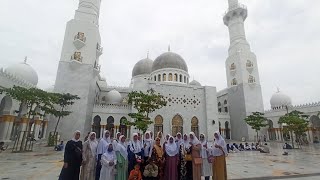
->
<box><xmin>244</xmin><ymin>112</ymin><xmax>268</xmax><ymax>140</ymax></box>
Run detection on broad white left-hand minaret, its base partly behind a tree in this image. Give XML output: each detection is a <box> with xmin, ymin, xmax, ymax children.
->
<box><xmin>49</xmin><ymin>0</ymin><xmax>102</xmax><ymax>140</ymax></box>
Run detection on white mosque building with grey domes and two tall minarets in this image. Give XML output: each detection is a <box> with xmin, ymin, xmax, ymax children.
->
<box><xmin>0</xmin><ymin>0</ymin><xmax>320</xmax><ymax>142</ymax></box>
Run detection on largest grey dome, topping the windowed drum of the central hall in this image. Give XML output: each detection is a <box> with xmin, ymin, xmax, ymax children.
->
<box><xmin>152</xmin><ymin>52</ymin><xmax>188</xmax><ymax>72</ymax></box>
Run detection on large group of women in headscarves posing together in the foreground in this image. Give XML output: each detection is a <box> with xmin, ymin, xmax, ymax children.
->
<box><xmin>59</xmin><ymin>130</ymin><xmax>228</xmax><ymax>180</ymax></box>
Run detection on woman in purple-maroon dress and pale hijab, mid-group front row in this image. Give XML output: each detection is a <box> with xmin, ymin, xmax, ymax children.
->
<box><xmin>165</xmin><ymin>136</ymin><xmax>179</xmax><ymax>180</ymax></box>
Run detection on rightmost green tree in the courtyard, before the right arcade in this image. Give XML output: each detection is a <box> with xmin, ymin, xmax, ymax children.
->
<box><xmin>278</xmin><ymin>110</ymin><xmax>309</xmax><ymax>148</ymax></box>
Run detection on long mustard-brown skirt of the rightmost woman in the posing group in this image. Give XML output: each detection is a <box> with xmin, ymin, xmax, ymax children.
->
<box><xmin>212</xmin><ymin>156</ymin><xmax>227</xmax><ymax>180</ymax></box>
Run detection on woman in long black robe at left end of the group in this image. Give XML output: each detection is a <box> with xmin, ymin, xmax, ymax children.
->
<box><xmin>59</xmin><ymin>130</ymin><xmax>82</xmax><ymax>180</ymax></box>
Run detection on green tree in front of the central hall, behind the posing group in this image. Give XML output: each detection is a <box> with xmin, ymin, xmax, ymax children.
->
<box><xmin>125</xmin><ymin>89</ymin><xmax>167</xmax><ymax>133</ymax></box>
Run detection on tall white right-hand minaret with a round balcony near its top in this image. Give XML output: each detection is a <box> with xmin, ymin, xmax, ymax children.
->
<box><xmin>223</xmin><ymin>0</ymin><xmax>264</xmax><ymax>139</ymax></box>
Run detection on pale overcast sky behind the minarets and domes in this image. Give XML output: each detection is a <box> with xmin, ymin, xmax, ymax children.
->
<box><xmin>0</xmin><ymin>0</ymin><xmax>320</xmax><ymax>109</ymax></box>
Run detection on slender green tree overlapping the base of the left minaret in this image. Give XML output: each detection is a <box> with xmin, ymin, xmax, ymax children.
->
<box><xmin>45</xmin><ymin>93</ymin><xmax>80</xmax><ymax>145</ymax></box>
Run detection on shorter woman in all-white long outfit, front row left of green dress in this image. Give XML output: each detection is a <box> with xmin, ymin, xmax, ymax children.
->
<box><xmin>100</xmin><ymin>143</ymin><xmax>117</xmax><ymax>180</ymax></box>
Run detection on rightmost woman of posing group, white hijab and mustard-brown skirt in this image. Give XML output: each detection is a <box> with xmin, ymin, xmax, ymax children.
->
<box><xmin>212</xmin><ymin>131</ymin><xmax>227</xmax><ymax>180</ymax></box>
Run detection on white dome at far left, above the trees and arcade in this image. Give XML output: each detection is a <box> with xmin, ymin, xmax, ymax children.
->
<box><xmin>5</xmin><ymin>60</ymin><xmax>38</xmax><ymax>86</ymax></box>
